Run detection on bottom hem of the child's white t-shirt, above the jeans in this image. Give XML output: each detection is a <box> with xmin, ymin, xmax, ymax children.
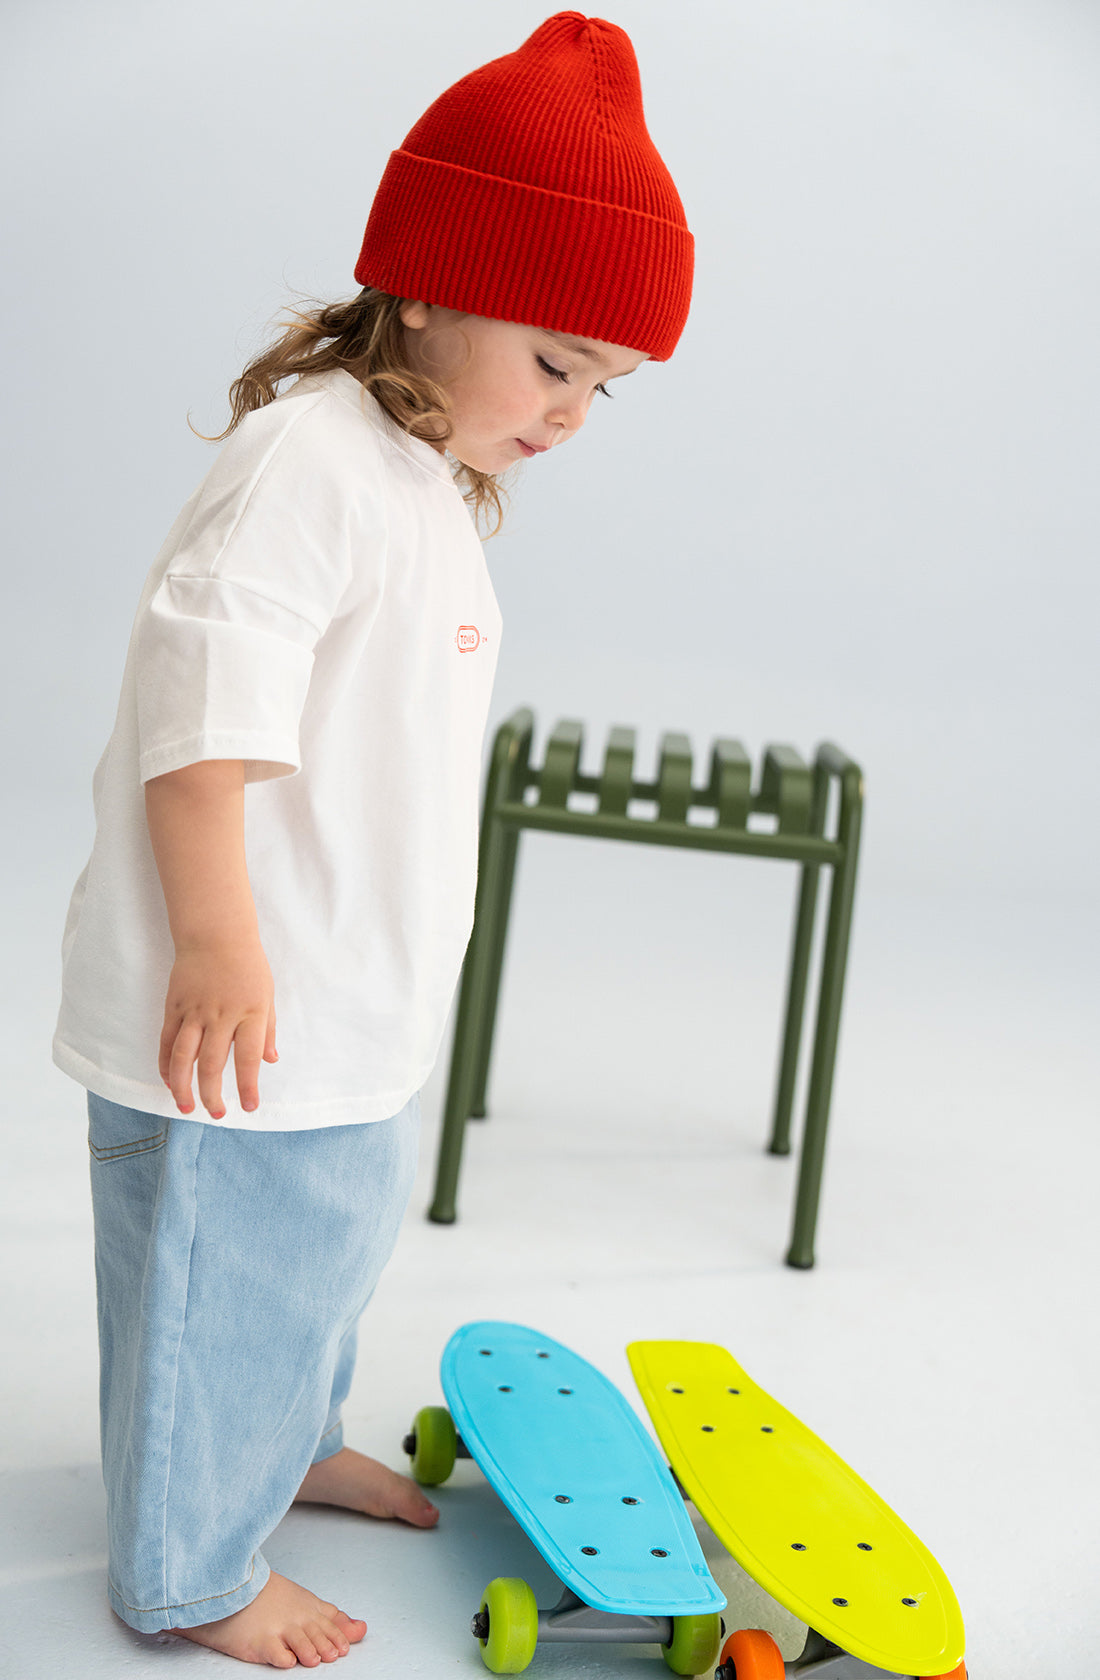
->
<box><xmin>54</xmin><ymin>1038</ymin><xmax>432</xmax><ymax>1132</ymax></box>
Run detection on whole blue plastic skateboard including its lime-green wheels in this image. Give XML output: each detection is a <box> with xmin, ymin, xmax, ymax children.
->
<box><xmin>405</xmin><ymin>1322</ymin><xmax>725</xmax><ymax>1675</ymax></box>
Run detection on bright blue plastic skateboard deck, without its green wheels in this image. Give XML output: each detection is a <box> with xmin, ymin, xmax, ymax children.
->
<box><xmin>442</xmin><ymin>1320</ymin><xmax>725</xmax><ymax>1616</ymax></box>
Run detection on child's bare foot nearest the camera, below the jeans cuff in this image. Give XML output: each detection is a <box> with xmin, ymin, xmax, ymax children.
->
<box><xmin>171</xmin><ymin>1571</ymin><xmax>366</xmax><ymax>1668</ymax></box>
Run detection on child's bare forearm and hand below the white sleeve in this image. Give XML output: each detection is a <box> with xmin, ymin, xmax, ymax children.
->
<box><xmin>144</xmin><ymin>759</ymin><xmax>277</xmax><ymax>1121</ymax></box>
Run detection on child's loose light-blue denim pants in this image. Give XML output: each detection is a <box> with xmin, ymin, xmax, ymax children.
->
<box><xmin>87</xmin><ymin>1094</ymin><xmax>420</xmax><ymax>1633</ymax></box>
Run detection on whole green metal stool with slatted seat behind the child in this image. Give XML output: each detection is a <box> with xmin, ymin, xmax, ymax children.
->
<box><xmin>428</xmin><ymin>707</ymin><xmax>863</xmax><ymax>1268</ymax></box>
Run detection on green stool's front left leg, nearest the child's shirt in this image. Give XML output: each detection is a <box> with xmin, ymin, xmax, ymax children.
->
<box><xmin>428</xmin><ymin>803</ymin><xmax>505</xmax><ymax>1225</ymax></box>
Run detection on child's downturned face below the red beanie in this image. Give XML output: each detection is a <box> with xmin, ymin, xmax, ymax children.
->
<box><xmin>401</xmin><ymin>302</ymin><xmax>647</xmax><ymax>472</ymax></box>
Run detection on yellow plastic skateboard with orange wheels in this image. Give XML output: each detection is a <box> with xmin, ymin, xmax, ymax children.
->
<box><xmin>626</xmin><ymin>1342</ymin><xmax>966</xmax><ymax>1680</ymax></box>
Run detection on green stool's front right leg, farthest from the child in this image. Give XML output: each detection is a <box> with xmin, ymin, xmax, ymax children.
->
<box><xmin>786</xmin><ymin>769</ymin><xmax>863</xmax><ymax>1270</ymax></box>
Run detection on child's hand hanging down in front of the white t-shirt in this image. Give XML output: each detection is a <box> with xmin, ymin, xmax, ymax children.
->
<box><xmin>160</xmin><ymin>939</ymin><xmax>279</xmax><ymax>1121</ymax></box>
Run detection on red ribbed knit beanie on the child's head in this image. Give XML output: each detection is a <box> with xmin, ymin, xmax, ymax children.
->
<box><xmin>354</xmin><ymin>12</ymin><xmax>694</xmax><ymax>361</ymax></box>
